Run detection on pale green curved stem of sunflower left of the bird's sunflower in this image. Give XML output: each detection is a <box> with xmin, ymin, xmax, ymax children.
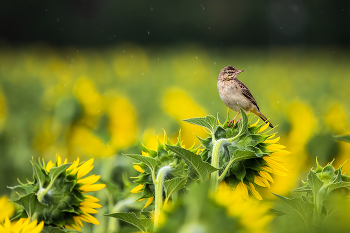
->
<box><xmin>154</xmin><ymin>166</ymin><xmax>171</xmax><ymax>231</ymax></box>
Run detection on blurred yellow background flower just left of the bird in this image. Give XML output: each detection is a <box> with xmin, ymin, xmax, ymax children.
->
<box><xmin>163</xmin><ymin>88</ymin><xmax>207</xmax><ymax>145</ymax></box>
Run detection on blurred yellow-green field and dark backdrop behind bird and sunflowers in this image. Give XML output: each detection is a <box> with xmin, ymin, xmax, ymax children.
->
<box><xmin>0</xmin><ymin>0</ymin><xmax>350</xmax><ymax>202</ymax></box>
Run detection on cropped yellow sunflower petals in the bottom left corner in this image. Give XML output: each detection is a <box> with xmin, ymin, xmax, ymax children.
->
<box><xmin>0</xmin><ymin>196</ymin><xmax>44</xmax><ymax>233</ymax></box>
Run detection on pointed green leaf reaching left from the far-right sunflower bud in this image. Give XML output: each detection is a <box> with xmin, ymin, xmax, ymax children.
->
<box><xmin>272</xmin><ymin>193</ymin><xmax>314</xmax><ymax>223</ymax></box>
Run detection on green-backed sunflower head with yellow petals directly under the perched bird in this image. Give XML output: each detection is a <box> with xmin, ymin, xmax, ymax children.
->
<box><xmin>185</xmin><ymin>110</ymin><xmax>289</xmax><ymax>199</ymax></box>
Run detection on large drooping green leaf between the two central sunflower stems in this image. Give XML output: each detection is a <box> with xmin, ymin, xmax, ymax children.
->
<box><xmin>166</xmin><ymin>145</ymin><xmax>218</xmax><ymax>181</ymax></box>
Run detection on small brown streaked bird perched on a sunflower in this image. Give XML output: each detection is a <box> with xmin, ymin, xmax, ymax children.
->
<box><xmin>217</xmin><ymin>66</ymin><xmax>273</xmax><ymax>128</ymax></box>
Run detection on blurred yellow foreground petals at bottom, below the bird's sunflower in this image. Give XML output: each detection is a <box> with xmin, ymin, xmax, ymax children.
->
<box><xmin>214</xmin><ymin>182</ymin><xmax>273</xmax><ymax>233</ymax></box>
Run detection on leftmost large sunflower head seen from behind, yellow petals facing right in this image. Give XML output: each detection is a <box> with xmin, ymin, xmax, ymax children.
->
<box><xmin>9</xmin><ymin>155</ymin><xmax>105</xmax><ymax>231</ymax></box>
